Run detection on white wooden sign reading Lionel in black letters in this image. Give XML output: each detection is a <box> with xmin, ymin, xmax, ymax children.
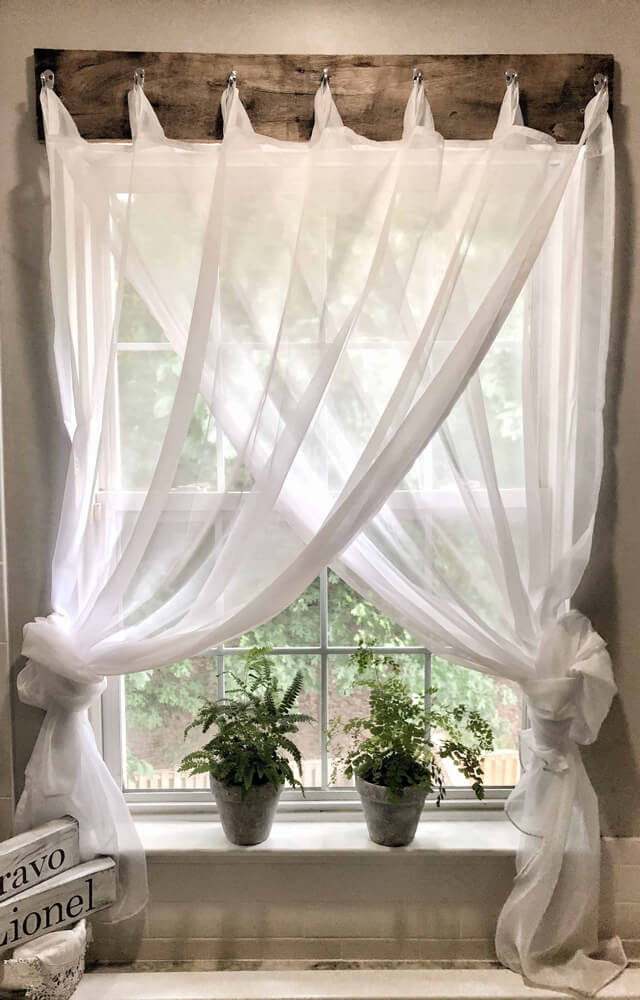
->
<box><xmin>0</xmin><ymin>858</ymin><xmax>116</xmax><ymax>952</ymax></box>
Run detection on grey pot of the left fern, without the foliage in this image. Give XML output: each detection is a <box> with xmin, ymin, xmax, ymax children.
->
<box><xmin>209</xmin><ymin>774</ymin><xmax>282</xmax><ymax>847</ymax></box>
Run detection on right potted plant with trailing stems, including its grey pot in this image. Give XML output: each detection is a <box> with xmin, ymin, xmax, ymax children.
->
<box><xmin>329</xmin><ymin>644</ymin><xmax>493</xmax><ymax>847</ymax></box>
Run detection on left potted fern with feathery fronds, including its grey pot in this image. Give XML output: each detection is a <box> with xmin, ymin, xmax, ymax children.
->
<box><xmin>180</xmin><ymin>647</ymin><xmax>313</xmax><ymax>846</ymax></box>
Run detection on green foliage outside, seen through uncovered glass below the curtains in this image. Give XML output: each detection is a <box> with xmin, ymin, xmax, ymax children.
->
<box><xmin>125</xmin><ymin>571</ymin><xmax>520</xmax><ymax>782</ymax></box>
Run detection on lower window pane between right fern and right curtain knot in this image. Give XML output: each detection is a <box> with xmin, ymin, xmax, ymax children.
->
<box><xmin>431</xmin><ymin>656</ymin><xmax>522</xmax><ymax>786</ymax></box>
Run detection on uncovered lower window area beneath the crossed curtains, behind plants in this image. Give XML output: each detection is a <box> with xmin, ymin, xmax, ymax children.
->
<box><xmin>117</xmin><ymin>570</ymin><xmax>521</xmax><ymax>792</ymax></box>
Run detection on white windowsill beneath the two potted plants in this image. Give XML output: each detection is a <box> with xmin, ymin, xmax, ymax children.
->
<box><xmin>136</xmin><ymin>810</ymin><xmax>519</xmax><ymax>862</ymax></box>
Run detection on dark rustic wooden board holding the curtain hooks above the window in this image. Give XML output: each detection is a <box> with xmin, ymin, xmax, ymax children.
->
<box><xmin>34</xmin><ymin>49</ymin><xmax>613</xmax><ymax>142</ymax></box>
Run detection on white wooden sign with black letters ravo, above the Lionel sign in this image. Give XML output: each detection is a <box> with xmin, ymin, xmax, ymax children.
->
<box><xmin>0</xmin><ymin>816</ymin><xmax>80</xmax><ymax>912</ymax></box>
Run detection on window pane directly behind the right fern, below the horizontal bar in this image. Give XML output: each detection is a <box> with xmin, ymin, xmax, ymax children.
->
<box><xmin>329</xmin><ymin>653</ymin><xmax>425</xmax><ymax>787</ymax></box>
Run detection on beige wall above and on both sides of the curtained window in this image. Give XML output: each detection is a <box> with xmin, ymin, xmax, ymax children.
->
<box><xmin>0</xmin><ymin>0</ymin><xmax>640</xmax><ymax>836</ymax></box>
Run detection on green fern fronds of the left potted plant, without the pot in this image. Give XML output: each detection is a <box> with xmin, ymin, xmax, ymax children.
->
<box><xmin>179</xmin><ymin>646</ymin><xmax>313</xmax><ymax>792</ymax></box>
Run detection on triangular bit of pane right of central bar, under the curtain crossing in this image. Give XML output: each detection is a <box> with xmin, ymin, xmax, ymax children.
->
<box><xmin>328</xmin><ymin>570</ymin><xmax>420</xmax><ymax>646</ymax></box>
